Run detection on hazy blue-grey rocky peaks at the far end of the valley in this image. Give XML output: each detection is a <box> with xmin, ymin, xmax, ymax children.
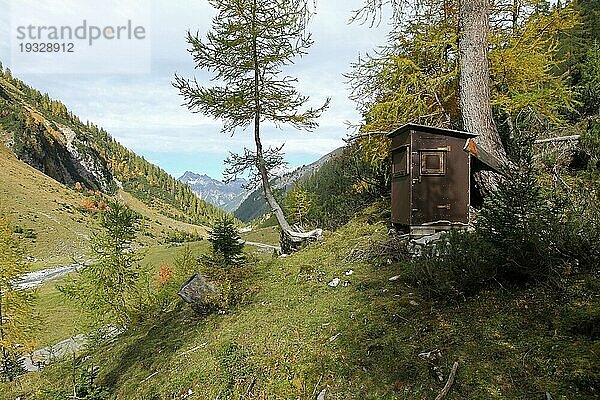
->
<box><xmin>177</xmin><ymin>171</ymin><xmax>248</xmax><ymax>212</ymax></box>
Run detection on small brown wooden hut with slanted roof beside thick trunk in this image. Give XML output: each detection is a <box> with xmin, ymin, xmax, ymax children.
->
<box><xmin>388</xmin><ymin>124</ymin><xmax>477</xmax><ymax>234</ymax></box>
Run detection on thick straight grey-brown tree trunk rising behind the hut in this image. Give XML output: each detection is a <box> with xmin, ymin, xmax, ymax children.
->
<box><xmin>458</xmin><ymin>0</ymin><xmax>506</xmax><ymax>194</ymax></box>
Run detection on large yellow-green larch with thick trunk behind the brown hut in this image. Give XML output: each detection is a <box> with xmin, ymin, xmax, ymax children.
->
<box><xmin>347</xmin><ymin>0</ymin><xmax>577</xmax><ymax>193</ymax></box>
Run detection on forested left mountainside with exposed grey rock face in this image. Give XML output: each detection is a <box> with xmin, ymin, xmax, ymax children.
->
<box><xmin>0</xmin><ymin>70</ymin><xmax>223</xmax><ymax>224</ymax></box>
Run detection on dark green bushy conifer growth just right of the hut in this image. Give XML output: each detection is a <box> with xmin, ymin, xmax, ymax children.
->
<box><xmin>408</xmin><ymin>139</ymin><xmax>600</xmax><ymax>298</ymax></box>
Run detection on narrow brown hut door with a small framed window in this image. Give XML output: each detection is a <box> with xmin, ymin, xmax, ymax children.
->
<box><xmin>412</xmin><ymin>137</ymin><xmax>452</xmax><ymax>225</ymax></box>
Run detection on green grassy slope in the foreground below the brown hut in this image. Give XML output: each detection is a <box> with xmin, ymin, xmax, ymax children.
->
<box><xmin>0</xmin><ymin>216</ymin><xmax>600</xmax><ymax>399</ymax></box>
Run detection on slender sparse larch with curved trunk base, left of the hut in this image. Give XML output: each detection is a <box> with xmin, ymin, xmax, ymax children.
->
<box><xmin>173</xmin><ymin>0</ymin><xmax>329</xmax><ymax>238</ymax></box>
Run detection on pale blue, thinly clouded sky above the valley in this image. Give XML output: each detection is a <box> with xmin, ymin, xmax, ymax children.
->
<box><xmin>0</xmin><ymin>0</ymin><xmax>388</xmax><ymax>179</ymax></box>
